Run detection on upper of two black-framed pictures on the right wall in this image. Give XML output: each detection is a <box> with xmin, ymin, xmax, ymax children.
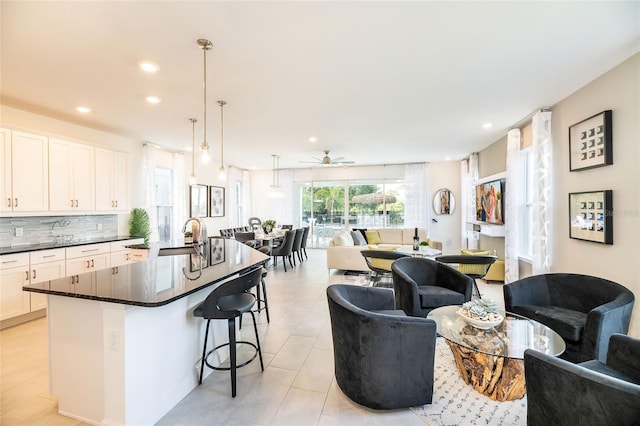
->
<box><xmin>569</xmin><ymin>110</ymin><xmax>613</xmax><ymax>172</ymax></box>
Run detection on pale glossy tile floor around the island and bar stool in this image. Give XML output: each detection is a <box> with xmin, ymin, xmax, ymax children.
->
<box><xmin>0</xmin><ymin>250</ymin><xmax>503</xmax><ymax>426</ymax></box>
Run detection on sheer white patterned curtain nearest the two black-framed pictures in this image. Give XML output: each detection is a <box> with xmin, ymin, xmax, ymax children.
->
<box><xmin>531</xmin><ymin>111</ymin><xmax>552</xmax><ymax>274</ymax></box>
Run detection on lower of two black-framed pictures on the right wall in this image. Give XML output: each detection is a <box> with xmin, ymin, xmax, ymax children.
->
<box><xmin>569</xmin><ymin>189</ymin><xmax>613</xmax><ymax>244</ymax></box>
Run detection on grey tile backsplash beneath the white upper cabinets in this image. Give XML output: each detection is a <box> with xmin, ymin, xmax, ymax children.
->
<box><xmin>0</xmin><ymin>214</ymin><xmax>118</xmax><ymax>247</ymax></box>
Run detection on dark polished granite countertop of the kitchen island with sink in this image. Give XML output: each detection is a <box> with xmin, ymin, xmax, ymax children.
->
<box><xmin>23</xmin><ymin>239</ymin><xmax>269</xmax><ymax>307</ymax></box>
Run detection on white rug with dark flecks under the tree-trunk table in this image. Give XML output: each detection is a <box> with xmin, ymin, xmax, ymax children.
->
<box><xmin>411</xmin><ymin>337</ymin><xmax>527</xmax><ymax>426</ymax></box>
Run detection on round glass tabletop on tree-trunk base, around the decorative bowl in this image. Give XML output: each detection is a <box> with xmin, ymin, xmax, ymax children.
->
<box><xmin>427</xmin><ymin>306</ymin><xmax>566</xmax><ymax>359</ymax></box>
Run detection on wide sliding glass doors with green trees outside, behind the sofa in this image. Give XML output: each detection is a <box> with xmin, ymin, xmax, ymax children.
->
<box><xmin>300</xmin><ymin>180</ymin><xmax>405</xmax><ymax>247</ymax></box>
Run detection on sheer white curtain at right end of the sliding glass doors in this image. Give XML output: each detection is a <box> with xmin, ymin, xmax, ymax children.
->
<box><xmin>404</xmin><ymin>163</ymin><xmax>431</xmax><ymax>230</ymax></box>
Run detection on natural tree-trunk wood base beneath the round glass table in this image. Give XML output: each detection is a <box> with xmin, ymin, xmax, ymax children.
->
<box><xmin>445</xmin><ymin>339</ymin><xmax>526</xmax><ymax>401</ymax></box>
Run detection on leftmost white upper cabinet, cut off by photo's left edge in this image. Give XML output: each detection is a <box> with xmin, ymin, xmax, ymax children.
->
<box><xmin>0</xmin><ymin>129</ymin><xmax>49</xmax><ymax>213</ymax></box>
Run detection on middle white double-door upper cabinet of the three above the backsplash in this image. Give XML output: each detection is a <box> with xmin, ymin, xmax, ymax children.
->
<box><xmin>49</xmin><ymin>139</ymin><xmax>95</xmax><ymax>211</ymax></box>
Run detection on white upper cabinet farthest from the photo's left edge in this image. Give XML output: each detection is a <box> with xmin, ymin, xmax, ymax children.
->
<box><xmin>95</xmin><ymin>148</ymin><xmax>129</xmax><ymax>211</ymax></box>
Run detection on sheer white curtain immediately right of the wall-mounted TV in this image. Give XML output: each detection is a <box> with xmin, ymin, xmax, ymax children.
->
<box><xmin>504</xmin><ymin>129</ymin><xmax>525</xmax><ymax>283</ymax></box>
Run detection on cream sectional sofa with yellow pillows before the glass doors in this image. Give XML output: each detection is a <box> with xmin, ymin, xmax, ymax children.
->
<box><xmin>327</xmin><ymin>228</ymin><xmax>442</xmax><ymax>272</ymax></box>
